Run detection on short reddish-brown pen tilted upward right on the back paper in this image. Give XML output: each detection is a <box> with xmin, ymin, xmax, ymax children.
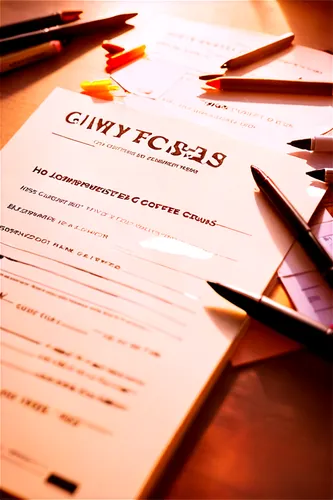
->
<box><xmin>221</xmin><ymin>32</ymin><xmax>295</xmax><ymax>69</ymax></box>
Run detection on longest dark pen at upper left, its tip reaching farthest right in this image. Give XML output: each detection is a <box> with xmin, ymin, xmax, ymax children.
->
<box><xmin>0</xmin><ymin>13</ymin><xmax>137</xmax><ymax>54</ymax></box>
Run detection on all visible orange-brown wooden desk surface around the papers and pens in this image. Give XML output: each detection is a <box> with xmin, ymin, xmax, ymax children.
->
<box><xmin>0</xmin><ymin>0</ymin><xmax>333</xmax><ymax>500</ymax></box>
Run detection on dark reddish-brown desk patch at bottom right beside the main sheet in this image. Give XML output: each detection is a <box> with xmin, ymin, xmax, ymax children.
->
<box><xmin>150</xmin><ymin>351</ymin><xmax>333</xmax><ymax>500</ymax></box>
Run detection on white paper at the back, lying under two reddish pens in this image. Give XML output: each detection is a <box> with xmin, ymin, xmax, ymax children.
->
<box><xmin>112</xmin><ymin>17</ymin><xmax>333</xmax><ymax>152</ymax></box>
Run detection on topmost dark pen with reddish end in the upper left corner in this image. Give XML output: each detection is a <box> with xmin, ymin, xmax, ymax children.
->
<box><xmin>0</xmin><ymin>10</ymin><xmax>83</xmax><ymax>38</ymax></box>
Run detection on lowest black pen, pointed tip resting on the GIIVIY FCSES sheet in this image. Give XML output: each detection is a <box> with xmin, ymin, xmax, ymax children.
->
<box><xmin>208</xmin><ymin>281</ymin><xmax>333</xmax><ymax>362</ymax></box>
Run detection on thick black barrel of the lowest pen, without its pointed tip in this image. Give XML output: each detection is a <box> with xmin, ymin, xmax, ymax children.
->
<box><xmin>258</xmin><ymin>297</ymin><xmax>333</xmax><ymax>361</ymax></box>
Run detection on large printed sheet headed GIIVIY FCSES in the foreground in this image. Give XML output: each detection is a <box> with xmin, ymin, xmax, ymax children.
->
<box><xmin>0</xmin><ymin>89</ymin><xmax>324</xmax><ymax>500</ymax></box>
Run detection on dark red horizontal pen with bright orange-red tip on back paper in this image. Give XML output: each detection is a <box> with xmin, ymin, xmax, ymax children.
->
<box><xmin>207</xmin><ymin>76</ymin><xmax>333</xmax><ymax>96</ymax></box>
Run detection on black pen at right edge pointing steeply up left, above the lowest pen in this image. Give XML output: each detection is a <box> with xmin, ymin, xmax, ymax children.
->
<box><xmin>251</xmin><ymin>165</ymin><xmax>333</xmax><ymax>288</ymax></box>
